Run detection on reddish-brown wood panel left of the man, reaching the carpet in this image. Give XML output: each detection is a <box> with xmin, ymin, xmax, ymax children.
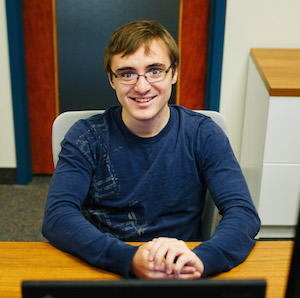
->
<box><xmin>22</xmin><ymin>0</ymin><xmax>56</xmax><ymax>174</ymax></box>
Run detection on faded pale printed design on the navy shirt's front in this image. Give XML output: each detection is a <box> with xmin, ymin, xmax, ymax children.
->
<box><xmin>77</xmin><ymin>123</ymin><xmax>148</xmax><ymax>240</ymax></box>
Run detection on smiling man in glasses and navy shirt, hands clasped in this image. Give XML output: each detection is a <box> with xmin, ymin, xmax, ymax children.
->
<box><xmin>43</xmin><ymin>21</ymin><xmax>260</xmax><ymax>279</ymax></box>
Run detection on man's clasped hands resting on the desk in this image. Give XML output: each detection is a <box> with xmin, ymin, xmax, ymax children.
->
<box><xmin>131</xmin><ymin>238</ymin><xmax>204</xmax><ymax>279</ymax></box>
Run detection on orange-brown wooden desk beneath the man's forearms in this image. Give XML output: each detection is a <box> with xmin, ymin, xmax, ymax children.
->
<box><xmin>0</xmin><ymin>241</ymin><xmax>293</xmax><ymax>298</ymax></box>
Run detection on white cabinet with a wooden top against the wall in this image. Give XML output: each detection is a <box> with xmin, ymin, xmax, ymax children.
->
<box><xmin>240</xmin><ymin>49</ymin><xmax>300</xmax><ymax>238</ymax></box>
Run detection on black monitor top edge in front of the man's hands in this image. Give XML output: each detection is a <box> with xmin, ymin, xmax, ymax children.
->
<box><xmin>22</xmin><ymin>279</ymin><xmax>266</xmax><ymax>298</ymax></box>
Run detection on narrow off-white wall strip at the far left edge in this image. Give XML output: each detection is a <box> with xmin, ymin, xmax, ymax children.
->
<box><xmin>0</xmin><ymin>0</ymin><xmax>16</xmax><ymax>168</ymax></box>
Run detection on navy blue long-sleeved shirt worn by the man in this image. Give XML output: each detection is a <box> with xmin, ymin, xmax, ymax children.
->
<box><xmin>43</xmin><ymin>106</ymin><xmax>260</xmax><ymax>277</ymax></box>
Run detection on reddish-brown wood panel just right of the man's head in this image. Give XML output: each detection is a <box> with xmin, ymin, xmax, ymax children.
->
<box><xmin>177</xmin><ymin>0</ymin><xmax>210</xmax><ymax>109</ymax></box>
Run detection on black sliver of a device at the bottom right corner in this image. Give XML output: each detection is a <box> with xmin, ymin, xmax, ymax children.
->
<box><xmin>285</xmin><ymin>210</ymin><xmax>300</xmax><ymax>298</ymax></box>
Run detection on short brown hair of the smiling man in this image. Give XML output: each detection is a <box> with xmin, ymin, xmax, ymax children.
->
<box><xmin>103</xmin><ymin>20</ymin><xmax>179</xmax><ymax>73</ymax></box>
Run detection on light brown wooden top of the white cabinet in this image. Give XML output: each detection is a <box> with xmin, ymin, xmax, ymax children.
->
<box><xmin>251</xmin><ymin>49</ymin><xmax>300</xmax><ymax>96</ymax></box>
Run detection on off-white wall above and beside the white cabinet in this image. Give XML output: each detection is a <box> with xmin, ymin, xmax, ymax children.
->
<box><xmin>220</xmin><ymin>0</ymin><xmax>300</xmax><ymax>159</ymax></box>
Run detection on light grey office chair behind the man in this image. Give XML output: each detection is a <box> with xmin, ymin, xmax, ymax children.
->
<box><xmin>52</xmin><ymin>110</ymin><xmax>228</xmax><ymax>240</ymax></box>
